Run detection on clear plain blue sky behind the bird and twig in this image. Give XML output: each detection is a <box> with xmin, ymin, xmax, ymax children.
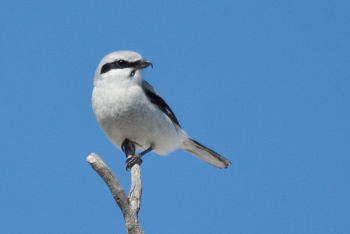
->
<box><xmin>0</xmin><ymin>0</ymin><xmax>350</xmax><ymax>234</ymax></box>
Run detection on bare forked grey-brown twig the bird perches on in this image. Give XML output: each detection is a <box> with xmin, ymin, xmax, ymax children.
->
<box><xmin>86</xmin><ymin>152</ymin><xmax>144</xmax><ymax>234</ymax></box>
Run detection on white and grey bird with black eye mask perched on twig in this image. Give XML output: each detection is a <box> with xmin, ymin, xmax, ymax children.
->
<box><xmin>91</xmin><ymin>50</ymin><xmax>231</xmax><ymax>169</ymax></box>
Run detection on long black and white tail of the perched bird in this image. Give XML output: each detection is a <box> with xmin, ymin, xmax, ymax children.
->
<box><xmin>181</xmin><ymin>138</ymin><xmax>231</xmax><ymax>168</ymax></box>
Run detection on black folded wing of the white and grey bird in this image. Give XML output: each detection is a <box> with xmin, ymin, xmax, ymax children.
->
<box><xmin>142</xmin><ymin>80</ymin><xmax>180</xmax><ymax>126</ymax></box>
